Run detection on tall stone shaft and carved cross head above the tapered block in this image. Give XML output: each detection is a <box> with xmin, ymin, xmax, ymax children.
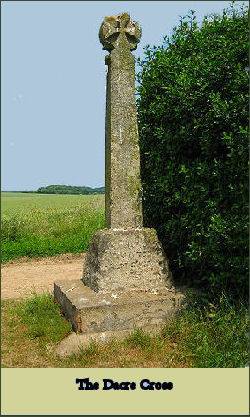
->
<box><xmin>99</xmin><ymin>13</ymin><xmax>142</xmax><ymax>229</ymax></box>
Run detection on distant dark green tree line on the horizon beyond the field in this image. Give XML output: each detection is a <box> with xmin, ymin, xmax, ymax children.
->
<box><xmin>37</xmin><ymin>185</ymin><xmax>105</xmax><ymax>194</ymax></box>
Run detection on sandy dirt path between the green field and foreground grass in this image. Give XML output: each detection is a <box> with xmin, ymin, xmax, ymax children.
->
<box><xmin>1</xmin><ymin>253</ymin><xmax>85</xmax><ymax>299</ymax></box>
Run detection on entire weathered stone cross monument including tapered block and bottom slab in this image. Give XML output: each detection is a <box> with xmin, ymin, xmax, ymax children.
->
<box><xmin>54</xmin><ymin>13</ymin><xmax>182</xmax><ymax>335</ymax></box>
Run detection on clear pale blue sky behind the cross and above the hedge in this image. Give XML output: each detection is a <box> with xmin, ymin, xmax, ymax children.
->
<box><xmin>1</xmin><ymin>1</ymin><xmax>247</xmax><ymax>190</ymax></box>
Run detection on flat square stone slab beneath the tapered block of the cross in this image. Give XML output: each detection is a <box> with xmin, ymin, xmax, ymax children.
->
<box><xmin>54</xmin><ymin>280</ymin><xmax>183</xmax><ymax>334</ymax></box>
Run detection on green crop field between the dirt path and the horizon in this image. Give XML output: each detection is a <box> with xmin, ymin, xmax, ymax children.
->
<box><xmin>1</xmin><ymin>192</ymin><xmax>105</xmax><ymax>261</ymax></box>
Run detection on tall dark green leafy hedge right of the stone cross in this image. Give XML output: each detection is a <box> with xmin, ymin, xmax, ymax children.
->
<box><xmin>138</xmin><ymin>5</ymin><xmax>249</xmax><ymax>295</ymax></box>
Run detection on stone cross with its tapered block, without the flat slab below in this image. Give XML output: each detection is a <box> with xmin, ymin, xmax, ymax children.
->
<box><xmin>82</xmin><ymin>13</ymin><xmax>171</xmax><ymax>292</ymax></box>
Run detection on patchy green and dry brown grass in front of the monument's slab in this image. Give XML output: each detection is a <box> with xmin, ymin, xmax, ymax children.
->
<box><xmin>2</xmin><ymin>294</ymin><xmax>248</xmax><ymax>367</ymax></box>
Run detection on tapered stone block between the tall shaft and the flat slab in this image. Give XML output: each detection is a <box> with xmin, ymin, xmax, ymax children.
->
<box><xmin>82</xmin><ymin>228</ymin><xmax>172</xmax><ymax>292</ymax></box>
